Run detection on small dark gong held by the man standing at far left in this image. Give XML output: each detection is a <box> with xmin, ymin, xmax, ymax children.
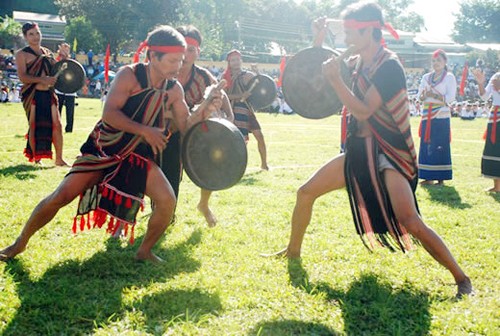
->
<box><xmin>51</xmin><ymin>59</ymin><xmax>85</xmax><ymax>93</ymax></box>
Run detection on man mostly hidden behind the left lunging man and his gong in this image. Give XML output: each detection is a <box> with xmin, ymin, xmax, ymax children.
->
<box><xmin>160</xmin><ymin>25</ymin><xmax>234</xmax><ymax>227</ymax></box>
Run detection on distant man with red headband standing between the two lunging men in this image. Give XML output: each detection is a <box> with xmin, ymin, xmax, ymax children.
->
<box><xmin>222</xmin><ymin>50</ymin><xmax>269</xmax><ymax>170</ymax></box>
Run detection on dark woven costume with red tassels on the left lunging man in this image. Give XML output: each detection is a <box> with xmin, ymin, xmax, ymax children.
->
<box><xmin>70</xmin><ymin>63</ymin><xmax>175</xmax><ymax>243</ymax></box>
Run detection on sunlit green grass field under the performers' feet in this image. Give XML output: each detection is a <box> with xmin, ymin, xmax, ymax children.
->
<box><xmin>0</xmin><ymin>99</ymin><xmax>500</xmax><ymax>336</ymax></box>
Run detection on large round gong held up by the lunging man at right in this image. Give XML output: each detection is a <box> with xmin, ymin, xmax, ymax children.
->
<box><xmin>282</xmin><ymin>47</ymin><xmax>350</xmax><ymax>119</ymax></box>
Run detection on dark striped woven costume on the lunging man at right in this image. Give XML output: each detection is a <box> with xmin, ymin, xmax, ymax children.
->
<box><xmin>344</xmin><ymin>47</ymin><xmax>417</xmax><ymax>251</ymax></box>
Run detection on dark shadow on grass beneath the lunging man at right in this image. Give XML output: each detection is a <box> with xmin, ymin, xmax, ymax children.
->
<box><xmin>288</xmin><ymin>259</ymin><xmax>431</xmax><ymax>335</ymax></box>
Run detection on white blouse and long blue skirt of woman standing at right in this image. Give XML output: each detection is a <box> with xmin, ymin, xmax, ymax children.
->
<box><xmin>418</xmin><ymin>69</ymin><xmax>457</xmax><ymax>180</ymax></box>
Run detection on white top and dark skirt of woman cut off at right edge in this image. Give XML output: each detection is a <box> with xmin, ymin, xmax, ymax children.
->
<box><xmin>481</xmin><ymin>73</ymin><xmax>500</xmax><ymax>179</ymax></box>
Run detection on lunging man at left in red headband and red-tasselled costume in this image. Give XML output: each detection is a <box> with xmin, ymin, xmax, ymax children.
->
<box><xmin>0</xmin><ymin>26</ymin><xmax>221</xmax><ymax>262</ymax></box>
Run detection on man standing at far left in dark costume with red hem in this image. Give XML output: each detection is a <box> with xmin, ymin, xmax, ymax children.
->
<box><xmin>16</xmin><ymin>22</ymin><xmax>70</xmax><ymax>166</ymax></box>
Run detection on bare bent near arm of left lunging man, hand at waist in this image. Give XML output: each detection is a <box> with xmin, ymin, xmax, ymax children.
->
<box><xmin>102</xmin><ymin>67</ymin><xmax>167</xmax><ymax>154</ymax></box>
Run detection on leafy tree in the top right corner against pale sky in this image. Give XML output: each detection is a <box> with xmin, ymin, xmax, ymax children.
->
<box><xmin>452</xmin><ymin>0</ymin><xmax>500</xmax><ymax>43</ymax></box>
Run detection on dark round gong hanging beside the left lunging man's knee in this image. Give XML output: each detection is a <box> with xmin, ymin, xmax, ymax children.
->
<box><xmin>182</xmin><ymin>118</ymin><xmax>247</xmax><ymax>190</ymax></box>
